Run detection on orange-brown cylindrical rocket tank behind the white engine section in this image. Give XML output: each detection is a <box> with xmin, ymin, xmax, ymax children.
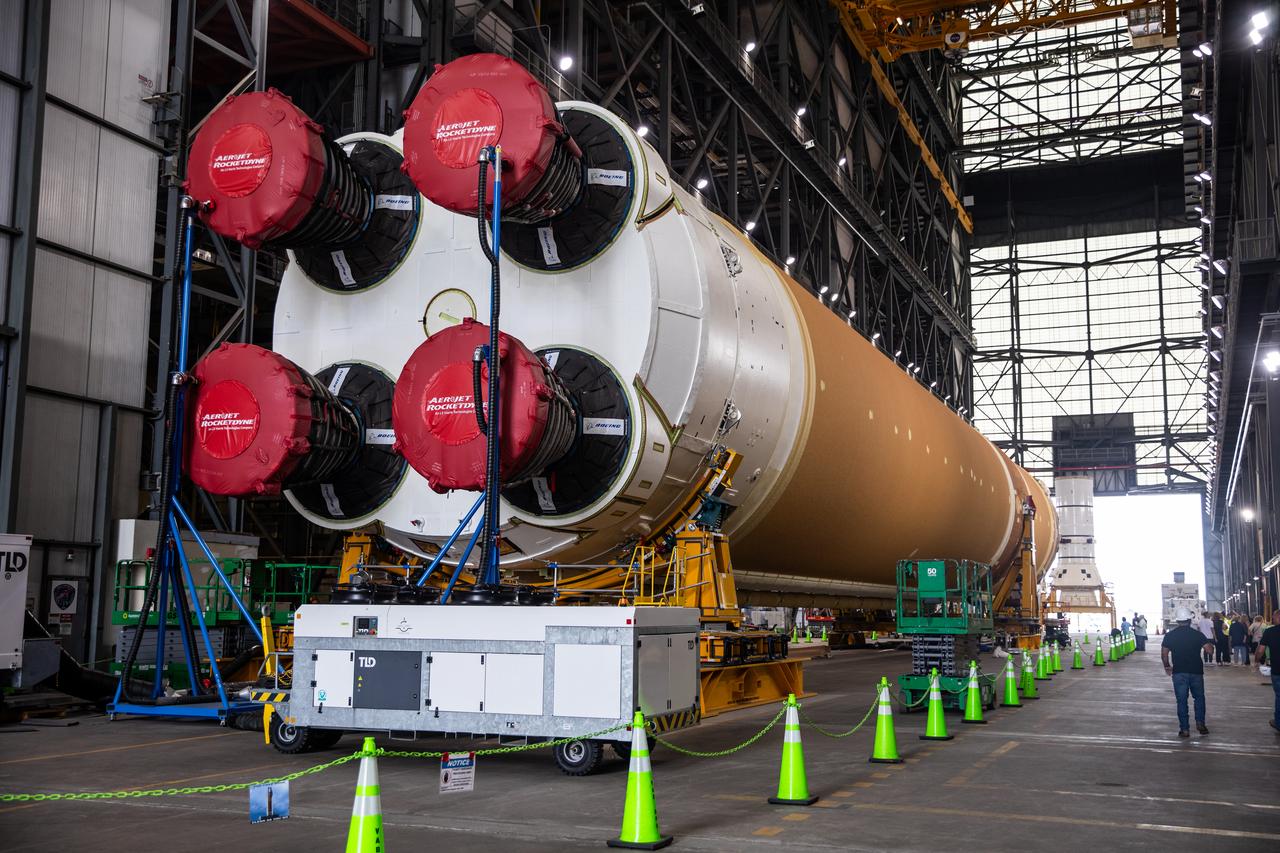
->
<box><xmin>733</xmin><ymin>275</ymin><xmax>1057</xmax><ymax>584</ymax></box>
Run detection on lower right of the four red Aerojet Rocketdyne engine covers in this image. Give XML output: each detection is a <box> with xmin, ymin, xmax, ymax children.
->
<box><xmin>392</xmin><ymin>318</ymin><xmax>553</xmax><ymax>493</ymax></box>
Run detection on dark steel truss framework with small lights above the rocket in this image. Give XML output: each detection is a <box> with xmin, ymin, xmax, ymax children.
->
<box><xmin>409</xmin><ymin>0</ymin><xmax>973</xmax><ymax>412</ymax></box>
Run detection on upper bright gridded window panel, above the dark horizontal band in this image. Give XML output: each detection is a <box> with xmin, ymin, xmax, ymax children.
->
<box><xmin>960</xmin><ymin>20</ymin><xmax>1184</xmax><ymax>172</ymax></box>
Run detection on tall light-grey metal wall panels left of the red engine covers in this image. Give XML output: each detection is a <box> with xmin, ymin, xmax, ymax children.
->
<box><xmin>16</xmin><ymin>0</ymin><xmax>169</xmax><ymax>653</ymax></box>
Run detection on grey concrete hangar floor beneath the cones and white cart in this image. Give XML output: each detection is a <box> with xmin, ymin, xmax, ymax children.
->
<box><xmin>0</xmin><ymin>640</ymin><xmax>1280</xmax><ymax>853</ymax></box>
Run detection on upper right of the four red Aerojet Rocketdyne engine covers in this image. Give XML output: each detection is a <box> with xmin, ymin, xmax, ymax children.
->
<box><xmin>401</xmin><ymin>54</ymin><xmax>564</xmax><ymax>216</ymax></box>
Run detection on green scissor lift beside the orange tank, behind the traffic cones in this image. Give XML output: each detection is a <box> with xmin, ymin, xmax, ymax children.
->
<box><xmin>897</xmin><ymin>560</ymin><xmax>996</xmax><ymax>710</ymax></box>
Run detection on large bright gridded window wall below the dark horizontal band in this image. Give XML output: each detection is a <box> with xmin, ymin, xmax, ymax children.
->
<box><xmin>972</xmin><ymin>219</ymin><xmax>1212</xmax><ymax>492</ymax></box>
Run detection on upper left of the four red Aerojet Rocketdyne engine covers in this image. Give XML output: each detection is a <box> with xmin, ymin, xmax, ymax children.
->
<box><xmin>183</xmin><ymin>88</ymin><xmax>325</xmax><ymax>248</ymax></box>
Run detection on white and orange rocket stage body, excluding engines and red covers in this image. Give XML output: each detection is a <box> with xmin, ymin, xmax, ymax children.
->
<box><xmin>274</xmin><ymin>101</ymin><xmax>1057</xmax><ymax>594</ymax></box>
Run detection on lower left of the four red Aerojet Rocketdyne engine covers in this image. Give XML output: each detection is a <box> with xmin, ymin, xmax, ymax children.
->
<box><xmin>186</xmin><ymin>343</ymin><xmax>320</xmax><ymax>494</ymax></box>
